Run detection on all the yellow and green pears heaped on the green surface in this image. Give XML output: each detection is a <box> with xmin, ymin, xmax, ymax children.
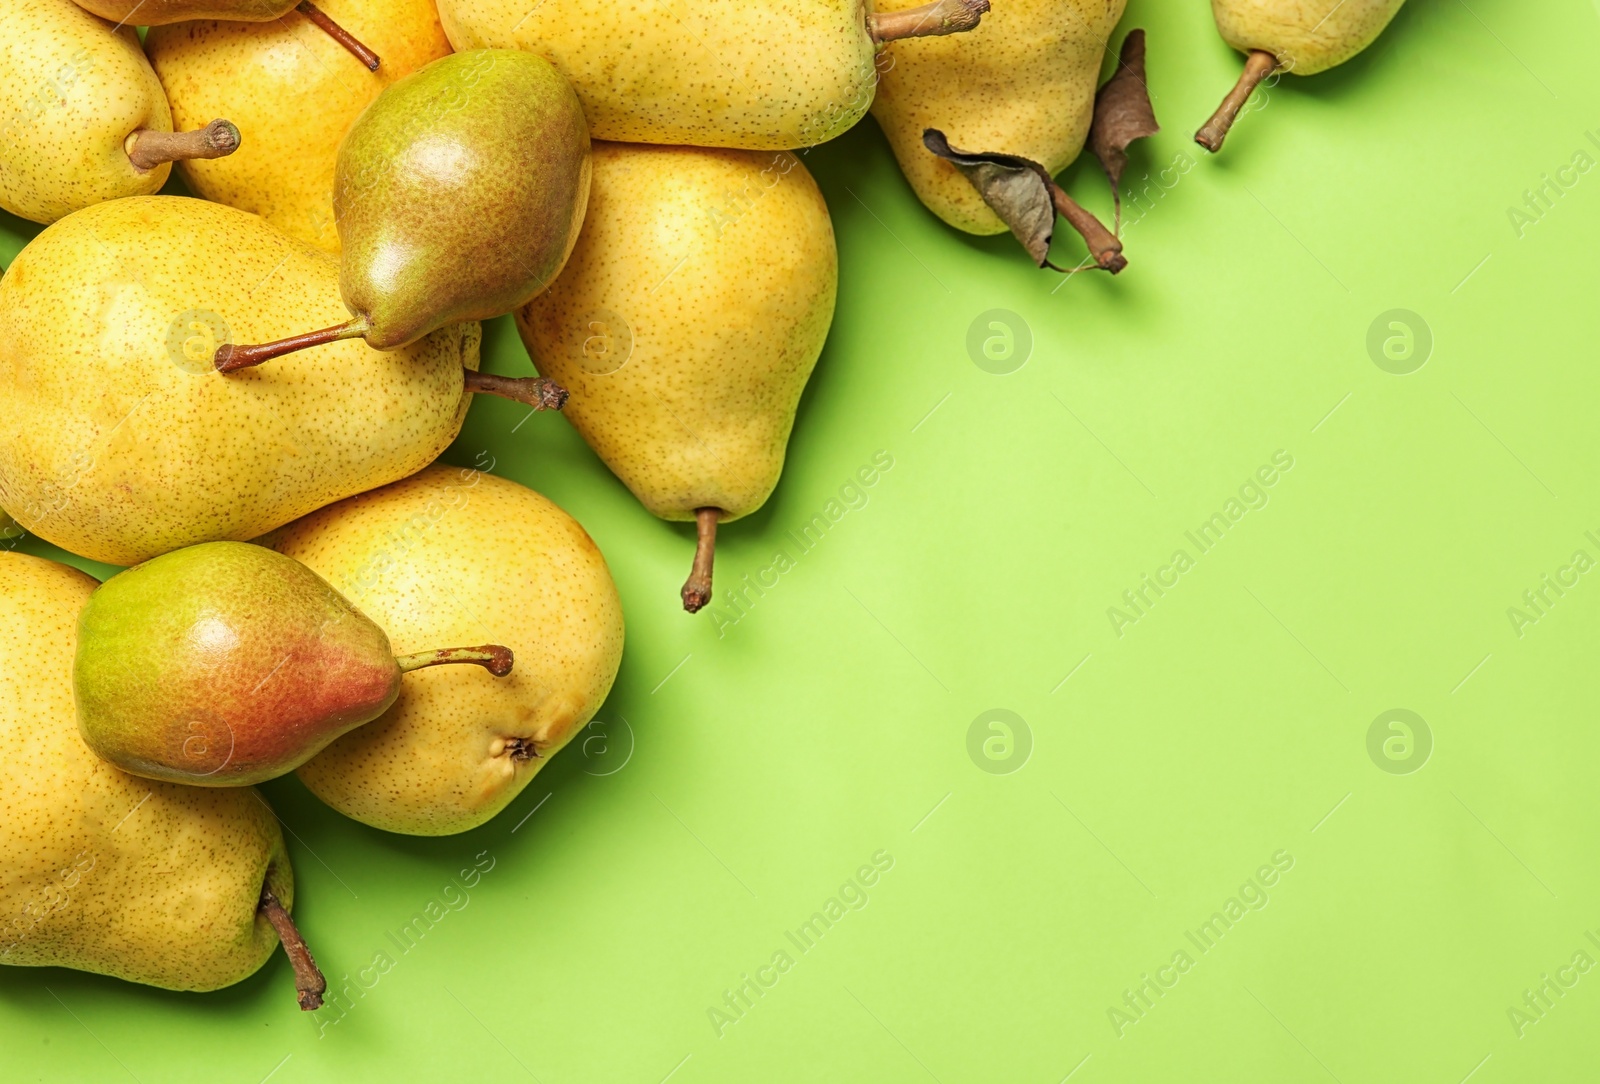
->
<box><xmin>0</xmin><ymin>0</ymin><xmax>1402</xmax><ymax>1009</ymax></box>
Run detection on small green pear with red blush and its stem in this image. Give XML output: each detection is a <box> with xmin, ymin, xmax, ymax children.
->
<box><xmin>72</xmin><ymin>542</ymin><xmax>512</xmax><ymax>787</ymax></box>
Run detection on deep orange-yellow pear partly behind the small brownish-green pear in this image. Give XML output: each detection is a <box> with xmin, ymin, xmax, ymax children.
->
<box><xmin>144</xmin><ymin>0</ymin><xmax>450</xmax><ymax>253</ymax></box>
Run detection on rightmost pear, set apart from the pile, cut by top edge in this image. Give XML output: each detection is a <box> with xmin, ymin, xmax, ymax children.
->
<box><xmin>1195</xmin><ymin>0</ymin><xmax>1405</xmax><ymax>153</ymax></box>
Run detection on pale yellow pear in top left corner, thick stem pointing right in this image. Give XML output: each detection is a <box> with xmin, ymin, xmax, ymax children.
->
<box><xmin>0</xmin><ymin>0</ymin><xmax>238</xmax><ymax>224</ymax></box>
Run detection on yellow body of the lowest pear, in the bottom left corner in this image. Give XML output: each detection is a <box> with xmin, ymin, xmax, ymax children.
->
<box><xmin>0</xmin><ymin>553</ymin><xmax>294</xmax><ymax>990</ymax></box>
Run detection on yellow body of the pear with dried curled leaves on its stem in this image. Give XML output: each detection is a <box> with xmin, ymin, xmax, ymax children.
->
<box><xmin>872</xmin><ymin>0</ymin><xmax>1126</xmax><ymax>233</ymax></box>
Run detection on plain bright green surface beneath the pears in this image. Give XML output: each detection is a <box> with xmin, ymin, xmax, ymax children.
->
<box><xmin>0</xmin><ymin>0</ymin><xmax>1600</xmax><ymax>1084</ymax></box>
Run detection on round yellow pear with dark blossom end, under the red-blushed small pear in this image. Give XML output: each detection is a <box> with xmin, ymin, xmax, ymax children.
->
<box><xmin>275</xmin><ymin>467</ymin><xmax>622</xmax><ymax>836</ymax></box>
